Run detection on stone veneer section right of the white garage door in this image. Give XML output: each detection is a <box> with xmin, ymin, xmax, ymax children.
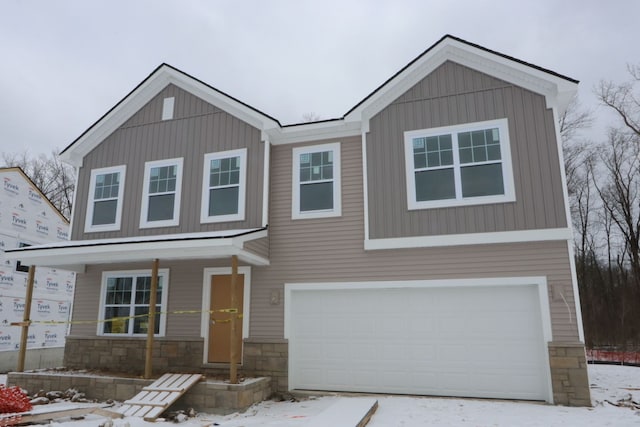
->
<box><xmin>549</xmin><ymin>342</ymin><xmax>591</xmax><ymax>406</ymax></box>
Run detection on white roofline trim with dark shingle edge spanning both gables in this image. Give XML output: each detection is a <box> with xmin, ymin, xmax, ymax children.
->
<box><xmin>60</xmin><ymin>34</ymin><xmax>578</xmax><ymax>159</ymax></box>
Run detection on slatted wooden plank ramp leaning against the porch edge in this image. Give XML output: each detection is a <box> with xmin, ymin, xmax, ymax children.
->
<box><xmin>118</xmin><ymin>374</ymin><xmax>203</xmax><ymax>421</ymax></box>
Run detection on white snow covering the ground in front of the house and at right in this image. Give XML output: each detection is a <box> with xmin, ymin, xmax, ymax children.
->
<box><xmin>0</xmin><ymin>365</ymin><xmax>640</xmax><ymax>427</ymax></box>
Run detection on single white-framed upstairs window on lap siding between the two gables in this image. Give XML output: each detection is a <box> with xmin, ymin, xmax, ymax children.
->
<box><xmin>291</xmin><ymin>142</ymin><xmax>342</xmax><ymax>219</ymax></box>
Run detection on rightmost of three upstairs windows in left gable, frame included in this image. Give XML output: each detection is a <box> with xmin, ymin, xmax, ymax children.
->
<box><xmin>200</xmin><ymin>148</ymin><xmax>247</xmax><ymax>223</ymax></box>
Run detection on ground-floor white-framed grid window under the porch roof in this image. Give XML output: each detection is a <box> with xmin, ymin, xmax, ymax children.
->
<box><xmin>98</xmin><ymin>269</ymin><xmax>169</xmax><ymax>336</ymax></box>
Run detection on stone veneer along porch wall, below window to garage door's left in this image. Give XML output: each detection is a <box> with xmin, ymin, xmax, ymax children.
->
<box><xmin>64</xmin><ymin>337</ymin><xmax>288</xmax><ymax>392</ymax></box>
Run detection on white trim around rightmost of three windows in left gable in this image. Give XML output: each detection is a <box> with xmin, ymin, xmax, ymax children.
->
<box><xmin>200</xmin><ymin>148</ymin><xmax>247</xmax><ymax>223</ymax></box>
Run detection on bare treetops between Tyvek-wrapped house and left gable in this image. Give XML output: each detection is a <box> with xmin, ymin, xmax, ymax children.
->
<box><xmin>0</xmin><ymin>151</ymin><xmax>75</xmax><ymax>219</ymax></box>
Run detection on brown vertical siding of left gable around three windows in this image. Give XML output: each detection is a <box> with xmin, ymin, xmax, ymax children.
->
<box><xmin>71</xmin><ymin>85</ymin><xmax>264</xmax><ymax>240</ymax></box>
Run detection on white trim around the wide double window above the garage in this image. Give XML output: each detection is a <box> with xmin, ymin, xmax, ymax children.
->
<box><xmin>404</xmin><ymin>118</ymin><xmax>515</xmax><ymax>210</ymax></box>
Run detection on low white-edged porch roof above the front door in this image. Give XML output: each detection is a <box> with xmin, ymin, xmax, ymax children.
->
<box><xmin>5</xmin><ymin>227</ymin><xmax>269</xmax><ymax>272</ymax></box>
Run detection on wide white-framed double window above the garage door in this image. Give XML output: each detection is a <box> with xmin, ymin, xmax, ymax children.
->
<box><xmin>405</xmin><ymin>119</ymin><xmax>515</xmax><ymax>209</ymax></box>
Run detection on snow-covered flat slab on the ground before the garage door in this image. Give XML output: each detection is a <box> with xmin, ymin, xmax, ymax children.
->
<box><xmin>306</xmin><ymin>397</ymin><xmax>378</xmax><ymax>427</ymax></box>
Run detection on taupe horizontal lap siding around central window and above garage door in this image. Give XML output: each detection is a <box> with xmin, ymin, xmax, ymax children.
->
<box><xmin>250</xmin><ymin>137</ymin><xmax>578</xmax><ymax>341</ymax></box>
